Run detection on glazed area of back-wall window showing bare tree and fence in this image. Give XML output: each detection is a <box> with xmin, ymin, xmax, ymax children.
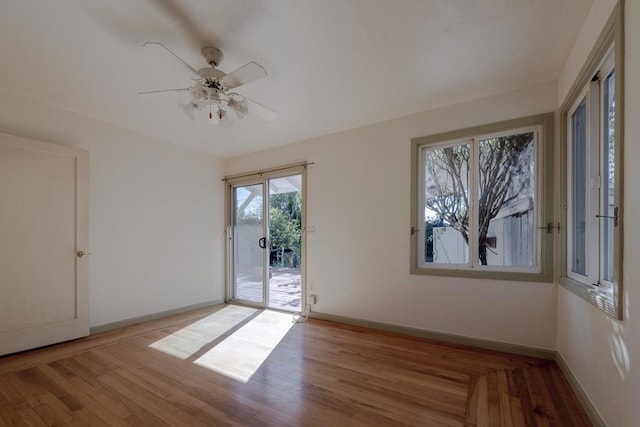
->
<box><xmin>423</xmin><ymin>131</ymin><xmax>536</xmax><ymax>267</ymax></box>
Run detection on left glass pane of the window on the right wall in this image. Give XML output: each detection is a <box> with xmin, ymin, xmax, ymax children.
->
<box><xmin>569</xmin><ymin>101</ymin><xmax>589</xmax><ymax>276</ymax></box>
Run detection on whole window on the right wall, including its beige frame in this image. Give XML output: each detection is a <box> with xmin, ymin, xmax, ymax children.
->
<box><xmin>560</xmin><ymin>1</ymin><xmax>623</xmax><ymax>318</ymax></box>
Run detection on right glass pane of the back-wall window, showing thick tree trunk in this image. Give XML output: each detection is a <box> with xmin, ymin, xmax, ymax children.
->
<box><xmin>477</xmin><ymin>132</ymin><xmax>536</xmax><ymax>267</ymax></box>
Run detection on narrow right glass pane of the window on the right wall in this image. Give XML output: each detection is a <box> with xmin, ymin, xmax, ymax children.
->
<box><xmin>600</xmin><ymin>72</ymin><xmax>616</xmax><ymax>282</ymax></box>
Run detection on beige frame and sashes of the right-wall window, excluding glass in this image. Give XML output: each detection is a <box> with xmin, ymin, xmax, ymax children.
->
<box><xmin>558</xmin><ymin>1</ymin><xmax>624</xmax><ymax>320</ymax></box>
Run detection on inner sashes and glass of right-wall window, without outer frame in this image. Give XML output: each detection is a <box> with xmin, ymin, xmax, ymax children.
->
<box><xmin>567</xmin><ymin>52</ymin><xmax>617</xmax><ymax>289</ymax></box>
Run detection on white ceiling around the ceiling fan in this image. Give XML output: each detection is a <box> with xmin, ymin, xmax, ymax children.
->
<box><xmin>0</xmin><ymin>0</ymin><xmax>592</xmax><ymax>157</ymax></box>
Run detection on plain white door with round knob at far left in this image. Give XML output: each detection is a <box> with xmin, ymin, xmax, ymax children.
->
<box><xmin>0</xmin><ymin>134</ymin><xmax>89</xmax><ymax>355</ymax></box>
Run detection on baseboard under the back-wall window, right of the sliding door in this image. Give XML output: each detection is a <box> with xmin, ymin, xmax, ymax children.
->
<box><xmin>309</xmin><ymin>312</ymin><xmax>556</xmax><ymax>360</ymax></box>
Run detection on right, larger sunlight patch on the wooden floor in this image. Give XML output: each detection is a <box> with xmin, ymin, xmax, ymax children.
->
<box><xmin>194</xmin><ymin>311</ymin><xmax>293</xmax><ymax>383</ymax></box>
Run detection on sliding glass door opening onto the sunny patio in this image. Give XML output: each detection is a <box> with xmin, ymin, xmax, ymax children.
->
<box><xmin>227</xmin><ymin>169</ymin><xmax>305</xmax><ymax>312</ymax></box>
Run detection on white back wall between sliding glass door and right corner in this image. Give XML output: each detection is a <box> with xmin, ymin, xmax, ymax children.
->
<box><xmin>226</xmin><ymin>83</ymin><xmax>557</xmax><ymax>349</ymax></box>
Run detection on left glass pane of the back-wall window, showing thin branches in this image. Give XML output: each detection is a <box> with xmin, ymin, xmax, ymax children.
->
<box><xmin>422</xmin><ymin>144</ymin><xmax>470</xmax><ymax>264</ymax></box>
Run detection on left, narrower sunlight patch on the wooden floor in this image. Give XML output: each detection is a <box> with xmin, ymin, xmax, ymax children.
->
<box><xmin>149</xmin><ymin>305</ymin><xmax>258</xmax><ymax>360</ymax></box>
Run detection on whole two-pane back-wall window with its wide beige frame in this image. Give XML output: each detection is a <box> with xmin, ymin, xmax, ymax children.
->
<box><xmin>411</xmin><ymin>113</ymin><xmax>554</xmax><ymax>281</ymax></box>
